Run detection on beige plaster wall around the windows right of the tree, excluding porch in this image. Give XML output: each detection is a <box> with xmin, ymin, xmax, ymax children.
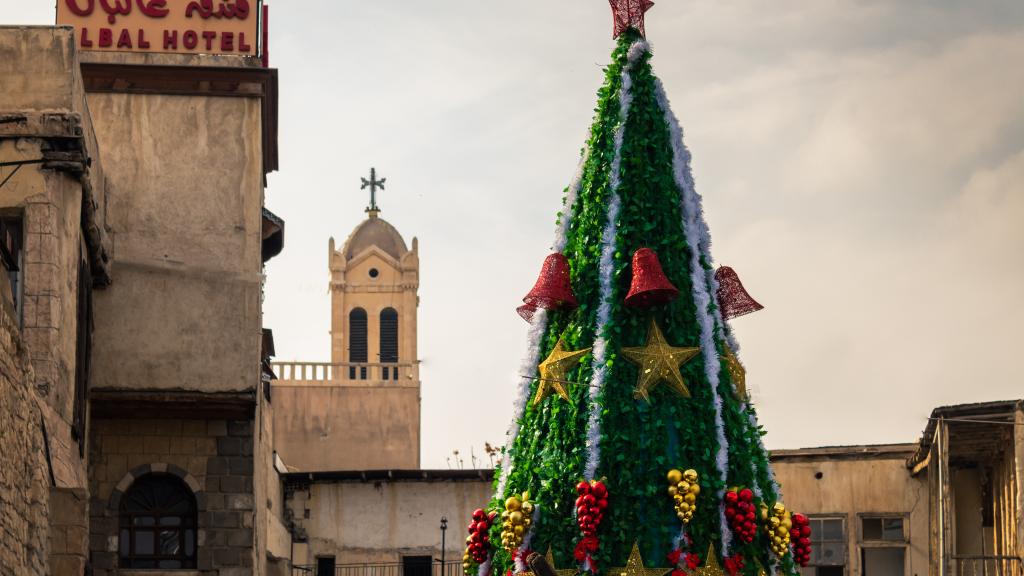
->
<box><xmin>772</xmin><ymin>445</ymin><xmax>929</xmax><ymax>576</ymax></box>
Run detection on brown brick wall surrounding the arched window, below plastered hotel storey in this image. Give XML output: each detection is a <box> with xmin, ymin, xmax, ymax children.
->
<box><xmin>89</xmin><ymin>419</ymin><xmax>254</xmax><ymax>576</ymax></box>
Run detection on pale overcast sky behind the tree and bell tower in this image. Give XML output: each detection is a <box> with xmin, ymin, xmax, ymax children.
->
<box><xmin>0</xmin><ymin>0</ymin><xmax>1024</xmax><ymax>467</ymax></box>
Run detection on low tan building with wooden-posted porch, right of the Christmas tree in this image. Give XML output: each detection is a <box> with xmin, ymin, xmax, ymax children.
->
<box><xmin>772</xmin><ymin>401</ymin><xmax>1024</xmax><ymax>576</ymax></box>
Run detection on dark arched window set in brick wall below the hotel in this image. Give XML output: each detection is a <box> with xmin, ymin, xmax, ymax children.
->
<box><xmin>118</xmin><ymin>474</ymin><xmax>197</xmax><ymax>569</ymax></box>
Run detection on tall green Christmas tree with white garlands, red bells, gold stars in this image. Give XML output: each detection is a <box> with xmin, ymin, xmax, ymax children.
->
<box><xmin>464</xmin><ymin>0</ymin><xmax>810</xmax><ymax>576</ymax></box>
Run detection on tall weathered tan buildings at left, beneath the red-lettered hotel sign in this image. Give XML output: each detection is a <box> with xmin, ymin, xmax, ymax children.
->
<box><xmin>0</xmin><ymin>19</ymin><xmax>283</xmax><ymax>576</ymax></box>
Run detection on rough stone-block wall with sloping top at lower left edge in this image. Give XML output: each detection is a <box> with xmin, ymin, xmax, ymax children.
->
<box><xmin>0</xmin><ymin>291</ymin><xmax>50</xmax><ymax>576</ymax></box>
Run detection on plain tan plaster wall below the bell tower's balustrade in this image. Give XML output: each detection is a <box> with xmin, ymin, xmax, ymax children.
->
<box><xmin>273</xmin><ymin>380</ymin><xmax>420</xmax><ymax>471</ymax></box>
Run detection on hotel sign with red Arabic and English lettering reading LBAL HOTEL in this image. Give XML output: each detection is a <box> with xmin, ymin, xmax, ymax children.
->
<box><xmin>57</xmin><ymin>0</ymin><xmax>259</xmax><ymax>56</ymax></box>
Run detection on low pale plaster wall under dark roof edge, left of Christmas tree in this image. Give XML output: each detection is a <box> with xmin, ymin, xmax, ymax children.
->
<box><xmin>286</xmin><ymin>480</ymin><xmax>492</xmax><ymax>565</ymax></box>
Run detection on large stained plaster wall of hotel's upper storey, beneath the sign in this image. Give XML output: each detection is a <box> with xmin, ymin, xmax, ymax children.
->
<box><xmin>88</xmin><ymin>89</ymin><xmax>263</xmax><ymax>392</ymax></box>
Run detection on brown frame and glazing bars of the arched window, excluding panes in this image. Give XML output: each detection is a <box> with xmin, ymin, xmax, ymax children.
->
<box><xmin>118</xmin><ymin>472</ymin><xmax>199</xmax><ymax>570</ymax></box>
